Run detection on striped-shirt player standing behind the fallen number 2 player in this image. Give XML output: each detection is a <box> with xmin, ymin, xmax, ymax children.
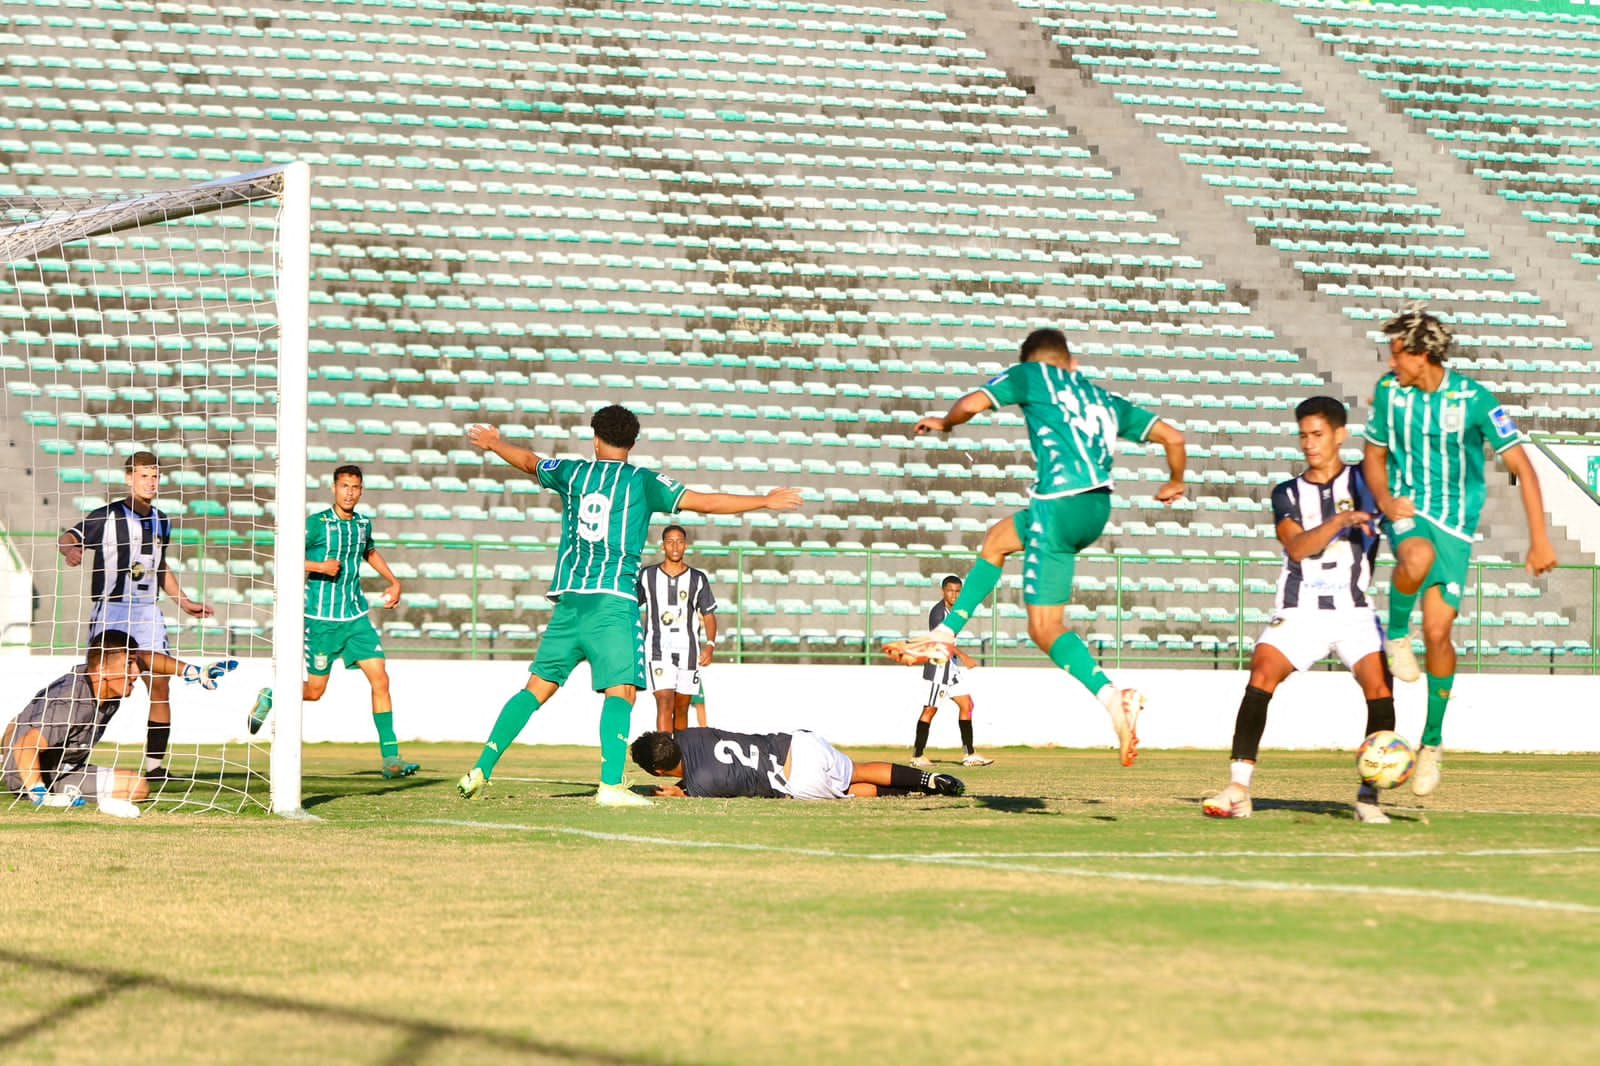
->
<box><xmin>638</xmin><ymin>525</ymin><xmax>717</xmax><ymax>733</ymax></box>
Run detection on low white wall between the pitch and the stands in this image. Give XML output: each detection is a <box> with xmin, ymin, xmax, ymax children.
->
<box><xmin>0</xmin><ymin>656</ymin><xmax>1600</xmax><ymax>752</ymax></box>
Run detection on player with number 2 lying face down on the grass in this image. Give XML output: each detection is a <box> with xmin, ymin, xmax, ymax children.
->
<box><xmin>632</xmin><ymin>728</ymin><xmax>966</xmax><ymax>799</ymax></box>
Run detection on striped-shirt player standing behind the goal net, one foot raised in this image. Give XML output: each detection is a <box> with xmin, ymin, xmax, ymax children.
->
<box><xmin>56</xmin><ymin>451</ymin><xmax>238</xmax><ymax>781</ymax></box>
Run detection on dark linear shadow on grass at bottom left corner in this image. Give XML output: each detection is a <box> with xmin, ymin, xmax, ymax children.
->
<box><xmin>0</xmin><ymin>949</ymin><xmax>658</xmax><ymax>1066</ymax></box>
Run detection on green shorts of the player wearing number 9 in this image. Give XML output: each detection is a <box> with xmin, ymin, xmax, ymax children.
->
<box><xmin>528</xmin><ymin>592</ymin><xmax>645</xmax><ymax>691</ymax></box>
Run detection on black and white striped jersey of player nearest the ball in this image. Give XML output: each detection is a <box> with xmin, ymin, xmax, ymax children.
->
<box><xmin>1272</xmin><ymin>464</ymin><xmax>1378</xmax><ymax>611</ymax></box>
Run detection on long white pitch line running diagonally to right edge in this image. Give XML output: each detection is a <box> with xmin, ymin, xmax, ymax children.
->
<box><xmin>411</xmin><ymin>818</ymin><xmax>1600</xmax><ymax>916</ymax></box>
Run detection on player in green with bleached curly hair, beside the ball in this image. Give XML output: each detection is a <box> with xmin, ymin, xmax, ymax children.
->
<box><xmin>1362</xmin><ymin>309</ymin><xmax>1555</xmax><ymax>795</ymax></box>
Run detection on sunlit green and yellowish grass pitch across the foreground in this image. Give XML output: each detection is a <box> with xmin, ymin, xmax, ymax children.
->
<box><xmin>0</xmin><ymin>744</ymin><xmax>1600</xmax><ymax>1064</ymax></box>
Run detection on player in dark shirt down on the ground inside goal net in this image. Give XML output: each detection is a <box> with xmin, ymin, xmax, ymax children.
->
<box><xmin>0</xmin><ymin>629</ymin><xmax>150</xmax><ymax>818</ymax></box>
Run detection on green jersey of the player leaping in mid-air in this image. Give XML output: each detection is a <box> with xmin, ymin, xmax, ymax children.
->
<box><xmin>979</xmin><ymin>363</ymin><xmax>1157</xmax><ymax>499</ymax></box>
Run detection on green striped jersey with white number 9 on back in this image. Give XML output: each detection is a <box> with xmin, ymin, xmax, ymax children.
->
<box><xmin>539</xmin><ymin>459</ymin><xmax>688</xmax><ymax>602</ymax></box>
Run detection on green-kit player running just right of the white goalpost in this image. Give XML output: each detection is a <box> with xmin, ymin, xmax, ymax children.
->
<box><xmin>250</xmin><ymin>464</ymin><xmax>419</xmax><ymax>778</ymax></box>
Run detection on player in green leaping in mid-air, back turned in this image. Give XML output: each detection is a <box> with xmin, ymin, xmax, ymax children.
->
<box><xmin>885</xmin><ymin>330</ymin><xmax>1187</xmax><ymax>767</ymax></box>
